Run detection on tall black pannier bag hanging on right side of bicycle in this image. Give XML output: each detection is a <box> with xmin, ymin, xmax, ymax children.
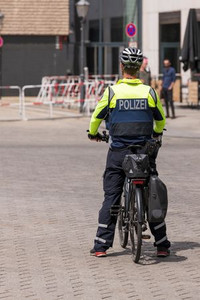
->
<box><xmin>148</xmin><ymin>175</ymin><xmax>168</xmax><ymax>222</ymax></box>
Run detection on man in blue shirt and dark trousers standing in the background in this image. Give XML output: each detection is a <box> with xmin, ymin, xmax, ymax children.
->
<box><xmin>161</xmin><ymin>59</ymin><xmax>176</xmax><ymax>119</ymax></box>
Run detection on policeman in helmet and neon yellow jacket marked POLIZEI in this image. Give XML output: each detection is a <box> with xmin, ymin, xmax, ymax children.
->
<box><xmin>88</xmin><ymin>48</ymin><xmax>170</xmax><ymax>257</ymax></box>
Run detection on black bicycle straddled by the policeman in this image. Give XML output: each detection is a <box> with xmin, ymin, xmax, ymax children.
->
<box><xmin>118</xmin><ymin>140</ymin><xmax>160</xmax><ymax>263</ymax></box>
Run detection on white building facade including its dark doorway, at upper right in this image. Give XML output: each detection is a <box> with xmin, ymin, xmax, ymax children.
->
<box><xmin>142</xmin><ymin>0</ymin><xmax>200</xmax><ymax>85</ymax></box>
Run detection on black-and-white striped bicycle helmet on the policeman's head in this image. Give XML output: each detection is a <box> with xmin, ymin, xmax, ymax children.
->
<box><xmin>120</xmin><ymin>47</ymin><xmax>143</xmax><ymax>67</ymax></box>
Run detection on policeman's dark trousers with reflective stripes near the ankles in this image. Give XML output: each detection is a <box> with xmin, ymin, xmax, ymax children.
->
<box><xmin>94</xmin><ymin>149</ymin><xmax>170</xmax><ymax>251</ymax></box>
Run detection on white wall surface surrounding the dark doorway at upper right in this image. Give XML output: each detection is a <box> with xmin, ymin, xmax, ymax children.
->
<box><xmin>142</xmin><ymin>0</ymin><xmax>200</xmax><ymax>84</ymax></box>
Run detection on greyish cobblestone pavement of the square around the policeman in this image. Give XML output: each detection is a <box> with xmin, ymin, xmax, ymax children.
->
<box><xmin>0</xmin><ymin>108</ymin><xmax>200</xmax><ymax>300</ymax></box>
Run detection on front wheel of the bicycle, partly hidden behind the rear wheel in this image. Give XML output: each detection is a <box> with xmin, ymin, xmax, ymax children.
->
<box><xmin>118</xmin><ymin>195</ymin><xmax>129</xmax><ymax>248</ymax></box>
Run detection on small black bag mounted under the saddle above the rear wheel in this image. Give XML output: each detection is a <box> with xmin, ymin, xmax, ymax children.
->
<box><xmin>122</xmin><ymin>154</ymin><xmax>149</xmax><ymax>178</ymax></box>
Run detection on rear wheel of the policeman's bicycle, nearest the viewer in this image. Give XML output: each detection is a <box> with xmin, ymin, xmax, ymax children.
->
<box><xmin>130</xmin><ymin>187</ymin><xmax>143</xmax><ymax>263</ymax></box>
